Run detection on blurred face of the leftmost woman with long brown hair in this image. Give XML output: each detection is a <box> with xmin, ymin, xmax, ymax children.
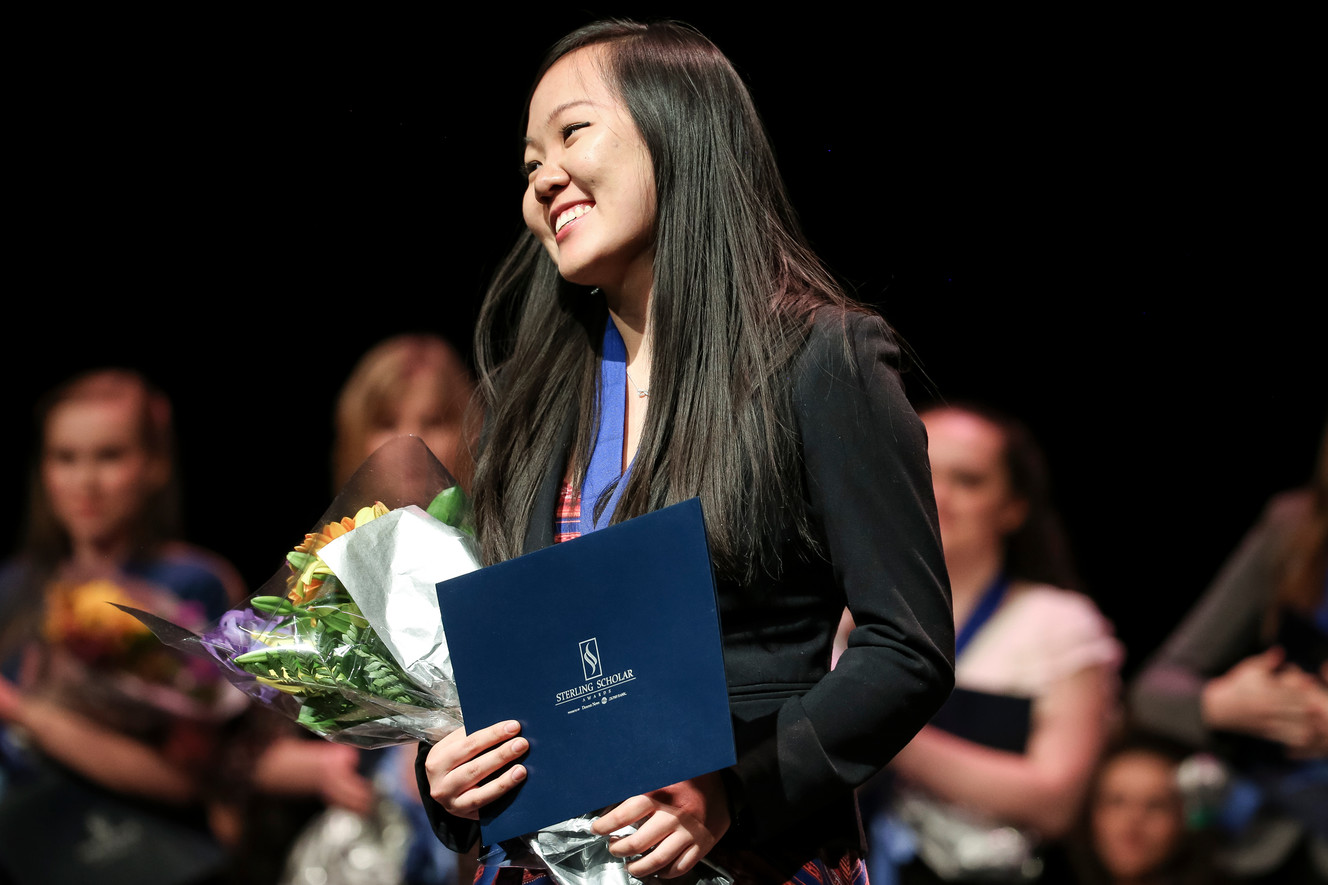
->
<box><xmin>41</xmin><ymin>399</ymin><xmax>163</xmax><ymax>547</ymax></box>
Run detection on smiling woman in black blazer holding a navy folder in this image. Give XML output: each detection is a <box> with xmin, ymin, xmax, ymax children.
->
<box><xmin>418</xmin><ymin>21</ymin><xmax>954</xmax><ymax>882</ymax></box>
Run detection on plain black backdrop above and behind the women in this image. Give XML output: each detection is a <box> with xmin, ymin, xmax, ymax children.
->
<box><xmin>0</xmin><ymin>10</ymin><xmax>1328</xmax><ymax>672</ymax></box>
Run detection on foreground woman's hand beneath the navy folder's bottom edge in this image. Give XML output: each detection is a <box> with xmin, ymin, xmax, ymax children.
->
<box><xmin>592</xmin><ymin>772</ymin><xmax>730</xmax><ymax>878</ymax></box>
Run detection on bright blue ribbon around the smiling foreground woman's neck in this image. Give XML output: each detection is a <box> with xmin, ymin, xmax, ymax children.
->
<box><xmin>580</xmin><ymin>316</ymin><xmax>632</xmax><ymax>534</ymax></box>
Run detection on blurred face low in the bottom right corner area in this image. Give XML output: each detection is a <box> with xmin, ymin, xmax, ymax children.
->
<box><xmin>1092</xmin><ymin>752</ymin><xmax>1183</xmax><ymax>878</ymax></box>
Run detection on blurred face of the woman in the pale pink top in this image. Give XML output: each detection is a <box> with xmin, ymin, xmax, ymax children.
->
<box><xmin>923</xmin><ymin>409</ymin><xmax>1028</xmax><ymax>557</ymax></box>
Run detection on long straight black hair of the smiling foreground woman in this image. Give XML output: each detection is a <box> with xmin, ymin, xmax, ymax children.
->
<box><xmin>474</xmin><ymin>20</ymin><xmax>849</xmax><ymax>579</ymax></box>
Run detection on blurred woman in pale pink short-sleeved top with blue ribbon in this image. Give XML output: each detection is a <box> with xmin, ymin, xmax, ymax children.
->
<box><xmin>867</xmin><ymin>407</ymin><xmax>1122</xmax><ymax>885</ymax></box>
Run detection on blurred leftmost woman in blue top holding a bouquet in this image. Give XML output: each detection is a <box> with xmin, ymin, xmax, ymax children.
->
<box><xmin>0</xmin><ymin>369</ymin><xmax>244</xmax><ymax>885</ymax></box>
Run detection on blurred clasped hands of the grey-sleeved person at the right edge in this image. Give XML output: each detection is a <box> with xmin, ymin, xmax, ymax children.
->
<box><xmin>1201</xmin><ymin>648</ymin><xmax>1328</xmax><ymax>756</ymax></box>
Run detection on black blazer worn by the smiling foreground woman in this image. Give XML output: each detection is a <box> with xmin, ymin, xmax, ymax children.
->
<box><xmin>417</xmin><ymin>308</ymin><xmax>955</xmax><ymax>876</ymax></box>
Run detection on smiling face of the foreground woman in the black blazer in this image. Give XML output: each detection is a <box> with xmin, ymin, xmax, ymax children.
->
<box><xmin>522</xmin><ymin>47</ymin><xmax>655</xmax><ymax>294</ymax></box>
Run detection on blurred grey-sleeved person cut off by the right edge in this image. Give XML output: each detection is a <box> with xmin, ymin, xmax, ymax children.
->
<box><xmin>1129</xmin><ymin>428</ymin><xmax>1328</xmax><ymax>882</ymax></box>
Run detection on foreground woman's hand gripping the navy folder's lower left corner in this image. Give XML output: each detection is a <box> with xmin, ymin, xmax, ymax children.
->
<box><xmin>424</xmin><ymin>720</ymin><xmax>530</xmax><ymax>820</ymax></box>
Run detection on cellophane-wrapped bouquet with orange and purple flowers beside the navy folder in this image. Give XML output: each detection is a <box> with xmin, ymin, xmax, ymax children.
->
<box><xmin>123</xmin><ymin>436</ymin><xmax>478</xmax><ymax>748</ymax></box>
